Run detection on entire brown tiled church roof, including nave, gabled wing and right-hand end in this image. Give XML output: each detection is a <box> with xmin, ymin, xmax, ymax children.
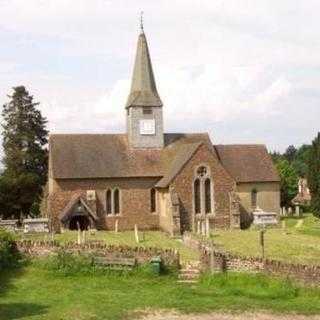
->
<box><xmin>49</xmin><ymin>133</ymin><xmax>279</xmax><ymax>187</ymax></box>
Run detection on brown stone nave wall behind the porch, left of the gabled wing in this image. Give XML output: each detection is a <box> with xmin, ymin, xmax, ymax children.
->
<box><xmin>49</xmin><ymin>178</ymin><xmax>159</xmax><ymax>230</ymax></box>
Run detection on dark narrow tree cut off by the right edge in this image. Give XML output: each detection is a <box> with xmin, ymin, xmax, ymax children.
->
<box><xmin>308</xmin><ymin>132</ymin><xmax>320</xmax><ymax>218</ymax></box>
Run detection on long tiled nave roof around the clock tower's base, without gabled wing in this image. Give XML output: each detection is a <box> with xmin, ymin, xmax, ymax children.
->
<box><xmin>49</xmin><ymin>133</ymin><xmax>211</xmax><ymax>179</ymax></box>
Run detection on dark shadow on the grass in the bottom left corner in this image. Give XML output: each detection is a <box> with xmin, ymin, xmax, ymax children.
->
<box><xmin>0</xmin><ymin>303</ymin><xmax>48</xmax><ymax>320</ymax></box>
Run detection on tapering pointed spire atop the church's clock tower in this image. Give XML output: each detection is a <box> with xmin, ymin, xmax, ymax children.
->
<box><xmin>126</xmin><ymin>24</ymin><xmax>162</xmax><ymax>108</ymax></box>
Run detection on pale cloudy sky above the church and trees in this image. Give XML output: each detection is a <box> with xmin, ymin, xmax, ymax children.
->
<box><xmin>0</xmin><ymin>0</ymin><xmax>320</xmax><ymax>155</ymax></box>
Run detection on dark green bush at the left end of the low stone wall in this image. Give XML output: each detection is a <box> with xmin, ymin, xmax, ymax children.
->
<box><xmin>0</xmin><ymin>229</ymin><xmax>21</xmax><ymax>271</ymax></box>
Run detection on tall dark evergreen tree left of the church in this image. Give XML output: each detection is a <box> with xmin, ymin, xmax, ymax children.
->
<box><xmin>0</xmin><ymin>86</ymin><xmax>48</xmax><ymax>216</ymax></box>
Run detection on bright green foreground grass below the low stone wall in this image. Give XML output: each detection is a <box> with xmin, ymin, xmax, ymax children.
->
<box><xmin>0</xmin><ymin>263</ymin><xmax>320</xmax><ymax>320</ymax></box>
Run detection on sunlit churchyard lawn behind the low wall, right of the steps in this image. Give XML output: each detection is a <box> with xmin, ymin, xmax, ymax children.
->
<box><xmin>212</xmin><ymin>214</ymin><xmax>320</xmax><ymax>265</ymax></box>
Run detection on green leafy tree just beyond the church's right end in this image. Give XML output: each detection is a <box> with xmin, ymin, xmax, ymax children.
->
<box><xmin>276</xmin><ymin>159</ymin><xmax>299</xmax><ymax>206</ymax></box>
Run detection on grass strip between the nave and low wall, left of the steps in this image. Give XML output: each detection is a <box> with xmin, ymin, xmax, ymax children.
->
<box><xmin>17</xmin><ymin>231</ymin><xmax>199</xmax><ymax>261</ymax></box>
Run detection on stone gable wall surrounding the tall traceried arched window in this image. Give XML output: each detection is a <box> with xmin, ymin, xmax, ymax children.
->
<box><xmin>172</xmin><ymin>145</ymin><xmax>236</xmax><ymax>231</ymax></box>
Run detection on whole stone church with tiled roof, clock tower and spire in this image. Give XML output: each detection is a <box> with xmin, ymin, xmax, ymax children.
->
<box><xmin>47</xmin><ymin>26</ymin><xmax>280</xmax><ymax>236</ymax></box>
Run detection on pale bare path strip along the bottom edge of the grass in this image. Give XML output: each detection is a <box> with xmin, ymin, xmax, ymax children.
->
<box><xmin>138</xmin><ymin>312</ymin><xmax>320</xmax><ymax>320</ymax></box>
